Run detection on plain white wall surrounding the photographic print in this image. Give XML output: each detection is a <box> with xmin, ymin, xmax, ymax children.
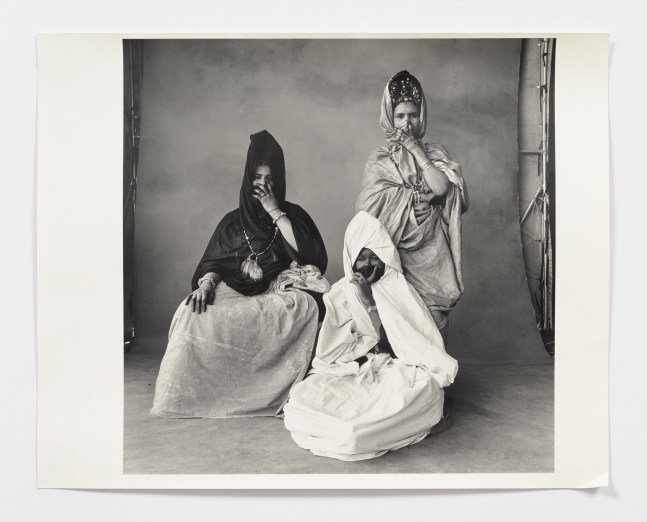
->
<box><xmin>5</xmin><ymin>0</ymin><xmax>647</xmax><ymax>521</ymax></box>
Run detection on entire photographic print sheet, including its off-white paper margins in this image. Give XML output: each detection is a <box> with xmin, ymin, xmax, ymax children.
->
<box><xmin>38</xmin><ymin>35</ymin><xmax>609</xmax><ymax>489</ymax></box>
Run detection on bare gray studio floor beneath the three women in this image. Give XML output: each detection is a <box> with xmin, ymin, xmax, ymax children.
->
<box><xmin>124</xmin><ymin>339</ymin><xmax>554</xmax><ymax>474</ymax></box>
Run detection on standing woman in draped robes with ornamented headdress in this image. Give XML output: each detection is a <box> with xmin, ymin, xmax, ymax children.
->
<box><xmin>356</xmin><ymin>71</ymin><xmax>469</xmax><ymax>344</ymax></box>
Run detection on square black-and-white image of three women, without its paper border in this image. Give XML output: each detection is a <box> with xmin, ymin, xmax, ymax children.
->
<box><xmin>122</xmin><ymin>37</ymin><xmax>556</xmax><ymax>475</ymax></box>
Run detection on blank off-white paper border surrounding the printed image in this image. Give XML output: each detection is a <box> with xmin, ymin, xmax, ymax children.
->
<box><xmin>37</xmin><ymin>34</ymin><xmax>609</xmax><ymax>489</ymax></box>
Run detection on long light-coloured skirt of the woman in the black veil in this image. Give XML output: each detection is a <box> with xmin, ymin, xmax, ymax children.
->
<box><xmin>151</xmin><ymin>265</ymin><xmax>330</xmax><ymax>418</ymax></box>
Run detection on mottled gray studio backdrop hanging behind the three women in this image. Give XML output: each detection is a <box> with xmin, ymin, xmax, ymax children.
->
<box><xmin>134</xmin><ymin>39</ymin><xmax>545</xmax><ymax>361</ymax></box>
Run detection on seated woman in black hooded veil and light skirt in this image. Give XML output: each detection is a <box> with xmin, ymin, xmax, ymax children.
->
<box><xmin>151</xmin><ymin>131</ymin><xmax>330</xmax><ymax>417</ymax></box>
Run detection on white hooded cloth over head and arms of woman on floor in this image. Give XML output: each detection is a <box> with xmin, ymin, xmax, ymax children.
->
<box><xmin>317</xmin><ymin>212</ymin><xmax>458</xmax><ymax>386</ymax></box>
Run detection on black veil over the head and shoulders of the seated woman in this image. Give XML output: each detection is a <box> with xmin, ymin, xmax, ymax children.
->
<box><xmin>191</xmin><ymin>131</ymin><xmax>328</xmax><ymax>295</ymax></box>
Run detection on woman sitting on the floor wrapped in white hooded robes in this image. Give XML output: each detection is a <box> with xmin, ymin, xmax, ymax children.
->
<box><xmin>284</xmin><ymin>212</ymin><xmax>458</xmax><ymax>460</ymax></box>
